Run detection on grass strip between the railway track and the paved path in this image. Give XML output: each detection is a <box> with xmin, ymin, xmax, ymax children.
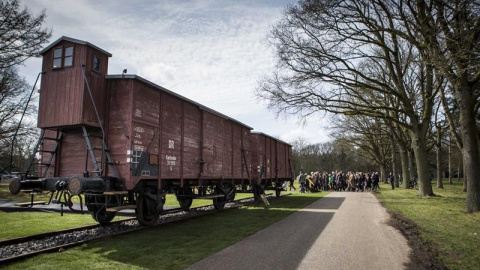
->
<box><xmin>1</xmin><ymin>192</ymin><xmax>328</xmax><ymax>270</ymax></box>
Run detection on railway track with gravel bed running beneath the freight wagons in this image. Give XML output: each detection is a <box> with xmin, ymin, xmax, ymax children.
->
<box><xmin>0</xmin><ymin>194</ymin><xmax>290</xmax><ymax>264</ymax></box>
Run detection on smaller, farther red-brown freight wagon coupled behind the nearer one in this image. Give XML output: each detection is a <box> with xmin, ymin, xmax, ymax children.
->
<box><xmin>250</xmin><ymin>131</ymin><xmax>294</xmax><ymax>197</ymax></box>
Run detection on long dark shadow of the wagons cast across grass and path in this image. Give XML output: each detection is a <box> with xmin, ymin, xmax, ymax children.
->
<box><xmin>82</xmin><ymin>195</ymin><xmax>345</xmax><ymax>269</ymax></box>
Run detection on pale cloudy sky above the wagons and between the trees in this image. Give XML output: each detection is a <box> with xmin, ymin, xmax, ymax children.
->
<box><xmin>19</xmin><ymin>0</ymin><xmax>330</xmax><ymax>146</ymax></box>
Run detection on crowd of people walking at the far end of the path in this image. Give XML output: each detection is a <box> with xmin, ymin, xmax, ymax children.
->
<box><xmin>289</xmin><ymin>171</ymin><xmax>380</xmax><ymax>193</ymax></box>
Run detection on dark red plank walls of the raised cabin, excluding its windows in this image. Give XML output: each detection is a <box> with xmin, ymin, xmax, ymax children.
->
<box><xmin>37</xmin><ymin>41</ymin><xmax>108</xmax><ymax>128</ymax></box>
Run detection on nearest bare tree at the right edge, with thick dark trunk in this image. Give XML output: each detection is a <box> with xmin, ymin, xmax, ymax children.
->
<box><xmin>402</xmin><ymin>0</ymin><xmax>480</xmax><ymax>212</ymax></box>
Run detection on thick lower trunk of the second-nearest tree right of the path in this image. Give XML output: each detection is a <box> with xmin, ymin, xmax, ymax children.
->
<box><xmin>411</xmin><ymin>132</ymin><xmax>434</xmax><ymax>197</ymax></box>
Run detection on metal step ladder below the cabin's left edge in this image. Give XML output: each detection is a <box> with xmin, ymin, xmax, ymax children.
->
<box><xmin>25</xmin><ymin>129</ymin><xmax>63</xmax><ymax>179</ymax></box>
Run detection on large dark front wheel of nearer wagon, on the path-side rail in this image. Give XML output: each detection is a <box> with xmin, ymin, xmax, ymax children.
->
<box><xmin>135</xmin><ymin>191</ymin><xmax>163</xmax><ymax>226</ymax></box>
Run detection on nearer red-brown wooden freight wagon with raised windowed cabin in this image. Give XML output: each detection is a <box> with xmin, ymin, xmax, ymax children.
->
<box><xmin>10</xmin><ymin>37</ymin><xmax>258</xmax><ymax>225</ymax></box>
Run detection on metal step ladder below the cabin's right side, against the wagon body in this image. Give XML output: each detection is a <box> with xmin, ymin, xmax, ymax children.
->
<box><xmin>82</xmin><ymin>126</ymin><xmax>118</xmax><ymax>177</ymax></box>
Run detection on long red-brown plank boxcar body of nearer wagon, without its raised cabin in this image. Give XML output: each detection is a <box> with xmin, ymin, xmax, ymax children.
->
<box><xmin>106</xmin><ymin>75</ymin><xmax>252</xmax><ymax>209</ymax></box>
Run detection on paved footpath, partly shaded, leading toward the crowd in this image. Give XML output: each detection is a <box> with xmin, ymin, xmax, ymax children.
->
<box><xmin>189</xmin><ymin>192</ymin><xmax>411</xmax><ymax>270</ymax></box>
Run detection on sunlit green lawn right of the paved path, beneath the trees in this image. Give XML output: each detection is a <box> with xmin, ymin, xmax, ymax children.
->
<box><xmin>378</xmin><ymin>179</ymin><xmax>480</xmax><ymax>270</ymax></box>
